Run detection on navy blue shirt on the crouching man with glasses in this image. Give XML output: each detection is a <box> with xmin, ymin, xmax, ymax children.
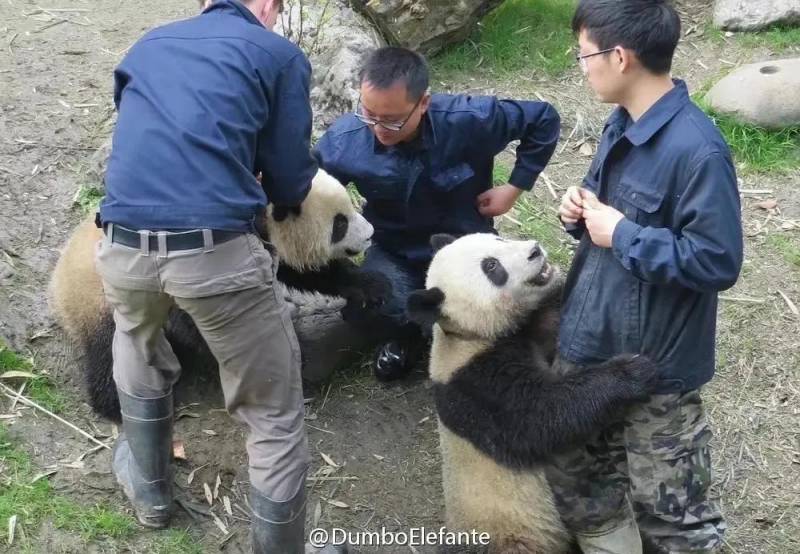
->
<box><xmin>316</xmin><ymin>94</ymin><xmax>560</xmax><ymax>263</ymax></box>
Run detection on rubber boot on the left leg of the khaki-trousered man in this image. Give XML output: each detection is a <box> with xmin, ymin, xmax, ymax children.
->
<box><xmin>112</xmin><ymin>391</ymin><xmax>172</xmax><ymax>529</ymax></box>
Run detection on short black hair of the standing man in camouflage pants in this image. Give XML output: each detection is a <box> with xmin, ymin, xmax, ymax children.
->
<box><xmin>572</xmin><ymin>0</ymin><xmax>681</xmax><ymax>75</ymax></box>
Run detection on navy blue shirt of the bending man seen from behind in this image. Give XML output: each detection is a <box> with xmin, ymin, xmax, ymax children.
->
<box><xmin>100</xmin><ymin>0</ymin><xmax>316</xmax><ymax>231</ymax></box>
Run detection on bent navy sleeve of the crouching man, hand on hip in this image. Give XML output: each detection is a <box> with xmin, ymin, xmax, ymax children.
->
<box><xmin>475</xmin><ymin>98</ymin><xmax>561</xmax><ymax>190</ymax></box>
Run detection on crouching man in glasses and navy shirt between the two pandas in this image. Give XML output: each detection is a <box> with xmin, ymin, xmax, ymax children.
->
<box><xmin>315</xmin><ymin>47</ymin><xmax>560</xmax><ymax>380</ymax></box>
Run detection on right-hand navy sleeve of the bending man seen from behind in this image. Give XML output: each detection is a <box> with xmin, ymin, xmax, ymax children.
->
<box><xmin>256</xmin><ymin>54</ymin><xmax>317</xmax><ymax>206</ymax></box>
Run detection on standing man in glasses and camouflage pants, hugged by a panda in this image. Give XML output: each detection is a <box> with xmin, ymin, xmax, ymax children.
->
<box><xmin>548</xmin><ymin>0</ymin><xmax>742</xmax><ymax>554</ymax></box>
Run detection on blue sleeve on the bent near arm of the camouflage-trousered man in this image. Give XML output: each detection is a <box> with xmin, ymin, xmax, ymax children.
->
<box><xmin>612</xmin><ymin>152</ymin><xmax>743</xmax><ymax>291</ymax></box>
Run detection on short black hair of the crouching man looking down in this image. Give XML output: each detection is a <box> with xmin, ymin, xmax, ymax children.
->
<box><xmin>361</xmin><ymin>46</ymin><xmax>430</xmax><ymax>101</ymax></box>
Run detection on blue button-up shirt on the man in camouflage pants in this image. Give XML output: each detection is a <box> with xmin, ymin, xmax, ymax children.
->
<box><xmin>559</xmin><ymin>81</ymin><xmax>742</xmax><ymax>393</ymax></box>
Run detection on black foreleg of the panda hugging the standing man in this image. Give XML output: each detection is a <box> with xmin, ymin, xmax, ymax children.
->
<box><xmin>434</xmin><ymin>343</ymin><xmax>656</xmax><ymax>468</ymax></box>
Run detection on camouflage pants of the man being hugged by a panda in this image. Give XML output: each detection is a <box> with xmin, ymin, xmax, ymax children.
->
<box><xmin>547</xmin><ymin>390</ymin><xmax>726</xmax><ymax>553</ymax></box>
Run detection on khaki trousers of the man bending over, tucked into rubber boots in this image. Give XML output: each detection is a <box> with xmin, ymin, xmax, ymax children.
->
<box><xmin>96</xmin><ymin>225</ymin><xmax>310</xmax><ymax>502</ymax></box>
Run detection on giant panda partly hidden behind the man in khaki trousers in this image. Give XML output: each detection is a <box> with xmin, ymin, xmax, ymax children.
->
<box><xmin>49</xmin><ymin>169</ymin><xmax>390</xmax><ymax>421</ymax></box>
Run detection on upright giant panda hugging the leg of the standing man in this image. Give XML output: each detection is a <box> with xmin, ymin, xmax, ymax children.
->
<box><xmin>408</xmin><ymin>234</ymin><xmax>656</xmax><ymax>554</ymax></box>
